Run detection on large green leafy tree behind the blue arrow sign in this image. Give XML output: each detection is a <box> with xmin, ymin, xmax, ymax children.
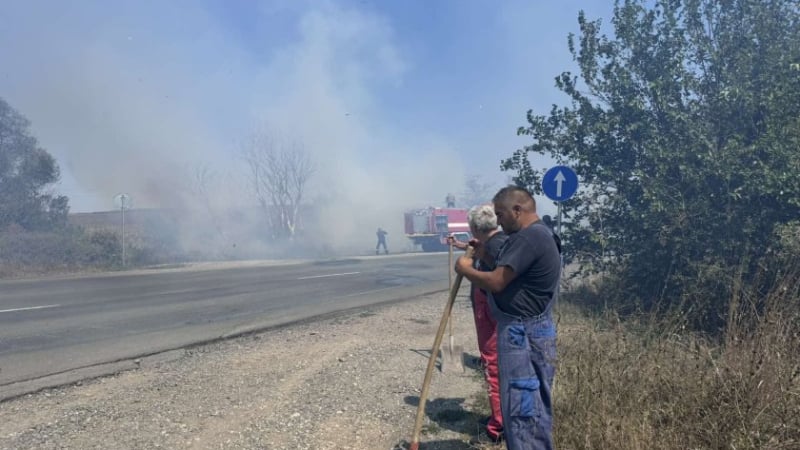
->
<box><xmin>501</xmin><ymin>0</ymin><xmax>800</xmax><ymax>325</ymax></box>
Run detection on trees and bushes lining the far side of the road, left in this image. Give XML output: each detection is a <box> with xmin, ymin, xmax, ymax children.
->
<box><xmin>0</xmin><ymin>97</ymin><xmax>327</xmax><ymax>279</ymax></box>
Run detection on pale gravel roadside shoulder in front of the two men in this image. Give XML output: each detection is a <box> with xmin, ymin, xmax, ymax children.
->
<box><xmin>0</xmin><ymin>290</ymin><xmax>500</xmax><ymax>450</ymax></box>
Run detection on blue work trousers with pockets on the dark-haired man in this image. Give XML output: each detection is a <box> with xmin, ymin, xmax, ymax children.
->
<box><xmin>490</xmin><ymin>299</ymin><xmax>556</xmax><ymax>450</ymax></box>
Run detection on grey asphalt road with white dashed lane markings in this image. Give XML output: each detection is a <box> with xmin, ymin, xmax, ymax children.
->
<box><xmin>0</xmin><ymin>253</ymin><xmax>448</xmax><ymax>398</ymax></box>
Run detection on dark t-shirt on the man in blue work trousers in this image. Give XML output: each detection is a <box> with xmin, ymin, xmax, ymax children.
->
<box><xmin>494</xmin><ymin>221</ymin><xmax>561</xmax><ymax>318</ymax></box>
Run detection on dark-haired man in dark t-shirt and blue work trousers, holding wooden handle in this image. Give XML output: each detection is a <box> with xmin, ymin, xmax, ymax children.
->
<box><xmin>456</xmin><ymin>186</ymin><xmax>561</xmax><ymax>450</ymax></box>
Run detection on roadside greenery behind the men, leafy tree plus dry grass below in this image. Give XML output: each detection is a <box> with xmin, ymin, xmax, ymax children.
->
<box><xmin>468</xmin><ymin>0</ymin><xmax>800</xmax><ymax>450</ymax></box>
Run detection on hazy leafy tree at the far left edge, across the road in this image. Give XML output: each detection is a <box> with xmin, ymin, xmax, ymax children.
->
<box><xmin>0</xmin><ymin>98</ymin><xmax>69</xmax><ymax>230</ymax></box>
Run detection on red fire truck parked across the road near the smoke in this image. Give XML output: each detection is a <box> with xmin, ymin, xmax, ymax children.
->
<box><xmin>405</xmin><ymin>207</ymin><xmax>471</xmax><ymax>252</ymax></box>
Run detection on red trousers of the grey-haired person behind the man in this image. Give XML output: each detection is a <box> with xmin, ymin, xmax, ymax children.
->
<box><xmin>472</xmin><ymin>285</ymin><xmax>503</xmax><ymax>439</ymax></box>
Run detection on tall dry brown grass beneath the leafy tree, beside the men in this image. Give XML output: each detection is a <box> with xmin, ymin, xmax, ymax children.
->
<box><xmin>468</xmin><ymin>268</ymin><xmax>800</xmax><ymax>450</ymax></box>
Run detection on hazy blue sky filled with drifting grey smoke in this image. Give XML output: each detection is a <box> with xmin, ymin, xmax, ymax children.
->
<box><xmin>0</xmin><ymin>0</ymin><xmax>613</xmax><ymax>218</ymax></box>
